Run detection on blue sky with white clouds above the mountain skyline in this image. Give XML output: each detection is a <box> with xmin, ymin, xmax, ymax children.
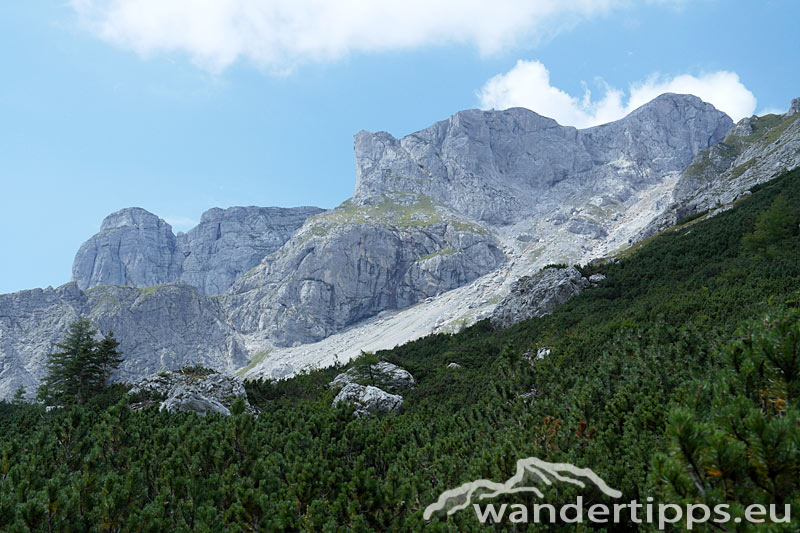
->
<box><xmin>0</xmin><ymin>0</ymin><xmax>800</xmax><ymax>293</ymax></box>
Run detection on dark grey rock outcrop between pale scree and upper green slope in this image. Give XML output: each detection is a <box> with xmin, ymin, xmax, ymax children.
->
<box><xmin>491</xmin><ymin>267</ymin><xmax>589</xmax><ymax>328</ymax></box>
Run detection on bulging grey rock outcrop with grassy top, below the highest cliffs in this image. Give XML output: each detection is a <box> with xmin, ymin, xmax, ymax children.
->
<box><xmin>222</xmin><ymin>194</ymin><xmax>505</xmax><ymax>346</ymax></box>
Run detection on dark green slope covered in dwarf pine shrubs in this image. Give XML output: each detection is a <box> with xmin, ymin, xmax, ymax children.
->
<box><xmin>0</xmin><ymin>171</ymin><xmax>800</xmax><ymax>531</ymax></box>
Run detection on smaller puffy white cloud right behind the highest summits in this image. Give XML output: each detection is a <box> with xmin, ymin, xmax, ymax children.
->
<box><xmin>478</xmin><ymin>60</ymin><xmax>756</xmax><ymax>128</ymax></box>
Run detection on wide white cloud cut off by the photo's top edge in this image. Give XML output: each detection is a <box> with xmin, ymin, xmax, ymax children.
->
<box><xmin>70</xmin><ymin>0</ymin><xmax>685</xmax><ymax>71</ymax></box>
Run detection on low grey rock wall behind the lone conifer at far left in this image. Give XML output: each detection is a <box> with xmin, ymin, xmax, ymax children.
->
<box><xmin>0</xmin><ymin>282</ymin><xmax>247</xmax><ymax>398</ymax></box>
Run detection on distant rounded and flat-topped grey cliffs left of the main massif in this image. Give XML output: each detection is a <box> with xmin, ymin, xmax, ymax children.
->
<box><xmin>72</xmin><ymin>207</ymin><xmax>322</xmax><ymax>295</ymax></box>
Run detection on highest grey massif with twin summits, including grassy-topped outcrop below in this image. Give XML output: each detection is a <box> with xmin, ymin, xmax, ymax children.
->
<box><xmin>223</xmin><ymin>94</ymin><xmax>732</xmax><ymax>354</ymax></box>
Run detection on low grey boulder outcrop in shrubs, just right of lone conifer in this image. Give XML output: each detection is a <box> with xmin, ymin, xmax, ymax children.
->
<box><xmin>129</xmin><ymin>371</ymin><xmax>251</xmax><ymax>416</ymax></box>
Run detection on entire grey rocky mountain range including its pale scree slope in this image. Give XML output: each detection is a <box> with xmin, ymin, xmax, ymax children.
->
<box><xmin>0</xmin><ymin>94</ymin><xmax>788</xmax><ymax>394</ymax></box>
